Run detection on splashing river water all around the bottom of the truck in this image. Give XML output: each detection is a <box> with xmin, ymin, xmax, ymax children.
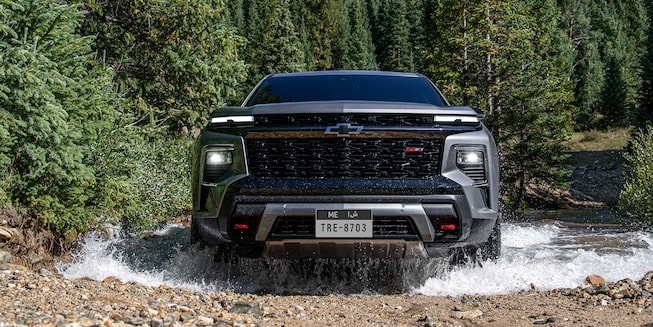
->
<box><xmin>57</xmin><ymin>211</ymin><xmax>653</xmax><ymax>296</ymax></box>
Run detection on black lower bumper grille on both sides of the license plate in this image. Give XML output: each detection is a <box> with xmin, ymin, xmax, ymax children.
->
<box><xmin>270</xmin><ymin>216</ymin><xmax>417</xmax><ymax>239</ymax></box>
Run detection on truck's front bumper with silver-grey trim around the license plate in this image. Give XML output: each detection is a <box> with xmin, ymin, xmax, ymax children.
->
<box><xmin>194</xmin><ymin>177</ymin><xmax>498</xmax><ymax>258</ymax></box>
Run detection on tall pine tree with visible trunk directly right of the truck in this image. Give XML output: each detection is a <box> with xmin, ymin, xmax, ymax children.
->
<box><xmin>488</xmin><ymin>1</ymin><xmax>574</xmax><ymax>205</ymax></box>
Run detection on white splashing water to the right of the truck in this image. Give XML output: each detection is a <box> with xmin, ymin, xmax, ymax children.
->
<box><xmin>414</xmin><ymin>225</ymin><xmax>653</xmax><ymax>296</ymax></box>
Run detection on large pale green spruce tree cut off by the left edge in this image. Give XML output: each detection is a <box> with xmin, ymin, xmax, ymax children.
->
<box><xmin>0</xmin><ymin>0</ymin><xmax>114</xmax><ymax>231</ymax></box>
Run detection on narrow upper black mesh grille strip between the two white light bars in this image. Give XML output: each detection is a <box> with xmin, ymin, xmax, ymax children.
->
<box><xmin>254</xmin><ymin>114</ymin><xmax>434</xmax><ymax>128</ymax></box>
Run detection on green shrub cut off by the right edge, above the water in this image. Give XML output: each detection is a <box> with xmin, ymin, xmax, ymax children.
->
<box><xmin>619</xmin><ymin>126</ymin><xmax>653</xmax><ymax>222</ymax></box>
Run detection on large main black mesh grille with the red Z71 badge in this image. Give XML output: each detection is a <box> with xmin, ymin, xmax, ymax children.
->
<box><xmin>246</xmin><ymin>138</ymin><xmax>442</xmax><ymax>178</ymax></box>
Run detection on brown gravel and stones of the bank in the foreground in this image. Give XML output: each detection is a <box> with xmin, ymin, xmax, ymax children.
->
<box><xmin>0</xmin><ymin>264</ymin><xmax>653</xmax><ymax>327</ymax></box>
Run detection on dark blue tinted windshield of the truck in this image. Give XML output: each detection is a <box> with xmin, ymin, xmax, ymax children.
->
<box><xmin>245</xmin><ymin>74</ymin><xmax>447</xmax><ymax>106</ymax></box>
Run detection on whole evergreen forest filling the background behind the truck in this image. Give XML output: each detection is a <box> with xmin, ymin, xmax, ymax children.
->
<box><xmin>0</xmin><ymin>0</ymin><xmax>653</xmax><ymax>237</ymax></box>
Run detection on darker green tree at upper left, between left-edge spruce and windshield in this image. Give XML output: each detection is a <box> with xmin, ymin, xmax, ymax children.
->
<box><xmin>82</xmin><ymin>0</ymin><xmax>246</xmax><ymax>133</ymax></box>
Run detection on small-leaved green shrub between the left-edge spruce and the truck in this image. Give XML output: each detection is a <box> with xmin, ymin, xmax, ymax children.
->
<box><xmin>88</xmin><ymin>127</ymin><xmax>193</xmax><ymax>231</ymax></box>
